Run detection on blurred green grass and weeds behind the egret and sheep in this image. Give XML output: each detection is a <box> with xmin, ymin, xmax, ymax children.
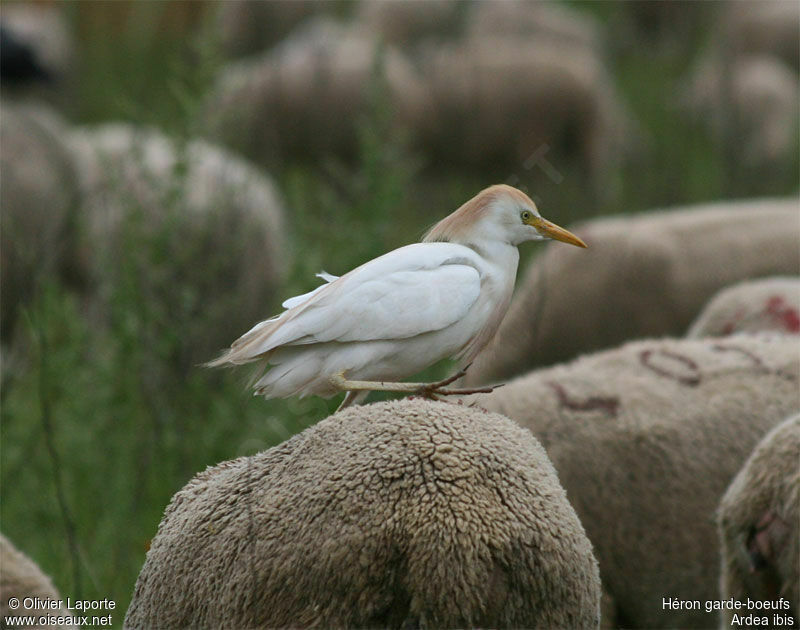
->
<box><xmin>0</xmin><ymin>0</ymin><xmax>798</xmax><ymax>625</ymax></box>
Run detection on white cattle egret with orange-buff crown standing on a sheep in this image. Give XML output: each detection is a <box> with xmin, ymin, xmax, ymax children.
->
<box><xmin>208</xmin><ymin>185</ymin><xmax>586</xmax><ymax>408</ymax></box>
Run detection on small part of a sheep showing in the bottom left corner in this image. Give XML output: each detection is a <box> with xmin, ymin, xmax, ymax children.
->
<box><xmin>0</xmin><ymin>534</ymin><xmax>77</xmax><ymax>629</ymax></box>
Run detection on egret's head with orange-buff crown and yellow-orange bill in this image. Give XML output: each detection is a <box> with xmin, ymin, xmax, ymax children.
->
<box><xmin>423</xmin><ymin>184</ymin><xmax>586</xmax><ymax>247</ymax></box>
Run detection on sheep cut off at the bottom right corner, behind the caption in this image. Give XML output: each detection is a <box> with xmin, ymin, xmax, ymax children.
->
<box><xmin>717</xmin><ymin>414</ymin><xmax>800</xmax><ymax>628</ymax></box>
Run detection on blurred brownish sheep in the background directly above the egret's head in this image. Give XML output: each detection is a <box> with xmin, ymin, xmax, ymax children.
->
<box><xmin>417</xmin><ymin>35</ymin><xmax>629</xmax><ymax>183</ymax></box>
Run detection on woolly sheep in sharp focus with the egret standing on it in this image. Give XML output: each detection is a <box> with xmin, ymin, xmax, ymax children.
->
<box><xmin>125</xmin><ymin>399</ymin><xmax>600</xmax><ymax>628</ymax></box>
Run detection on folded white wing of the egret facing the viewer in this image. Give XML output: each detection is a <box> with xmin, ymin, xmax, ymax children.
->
<box><xmin>219</xmin><ymin>243</ymin><xmax>481</xmax><ymax>363</ymax></box>
